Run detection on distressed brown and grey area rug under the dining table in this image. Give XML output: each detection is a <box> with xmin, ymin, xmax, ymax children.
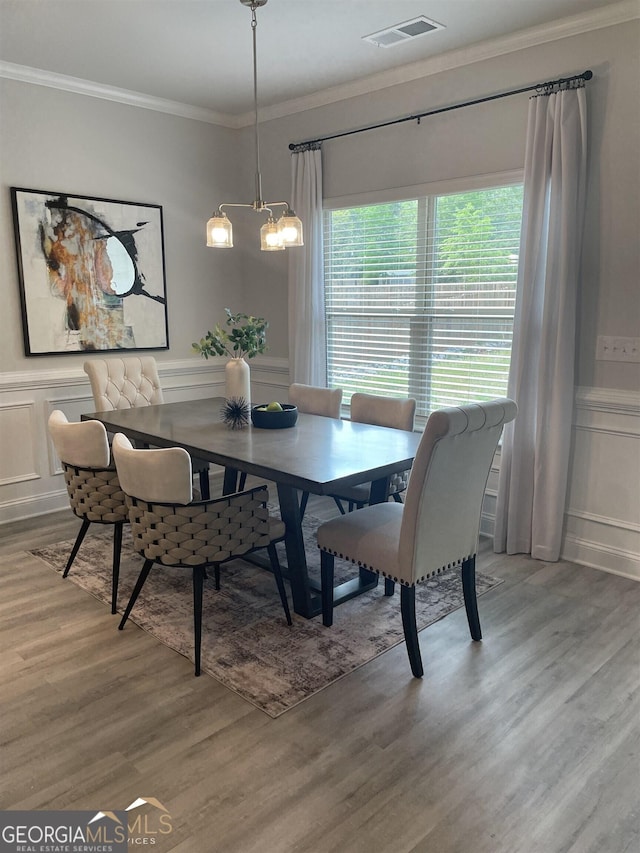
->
<box><xmin>30</xmin><ymin>515</ymin><xmax>501</xmax><ymax>717</ymax></box>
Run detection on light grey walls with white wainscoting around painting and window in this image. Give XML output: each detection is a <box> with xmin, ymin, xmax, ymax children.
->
<box><xmin>0</xmin><ymin>20</ymin><xmax>640</xmax><ymax>578</ymax></box>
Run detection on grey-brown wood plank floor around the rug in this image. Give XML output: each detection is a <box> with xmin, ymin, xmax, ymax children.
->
<box><xmin>0</xmin><ymin>498</ymin><xmax>640</xmax><ymax>853</ymax></box>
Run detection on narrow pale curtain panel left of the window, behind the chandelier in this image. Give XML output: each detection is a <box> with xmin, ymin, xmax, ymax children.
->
<box><xmin>287</xmin><ymin>146</ymin><xmax>327</xmax><ymax>386</ymax></box>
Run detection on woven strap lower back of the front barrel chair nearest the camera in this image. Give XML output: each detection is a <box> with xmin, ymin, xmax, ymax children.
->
<box><xmin>128</xmin><ymin>489</ymin><xmax>278</xmax><ymax>566</ymax></box>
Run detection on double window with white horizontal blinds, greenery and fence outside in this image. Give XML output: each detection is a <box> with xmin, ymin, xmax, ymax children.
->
<box><xmin>324</xmin><ymin>185</ymin><xmax>522</xmax><ymax>416</ymax></box>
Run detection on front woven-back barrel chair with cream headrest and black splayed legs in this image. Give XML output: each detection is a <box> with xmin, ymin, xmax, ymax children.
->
<box><xmin>113</xmin><ymin>433</ymin><xmax>291</xmax><ymax>675</ymax></box>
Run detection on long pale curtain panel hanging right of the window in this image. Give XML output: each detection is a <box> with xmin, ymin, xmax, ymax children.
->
<box><xmin>494</xmin><ymin>88</ymin><xmax>587</xmax><ymax>561</ymax></box>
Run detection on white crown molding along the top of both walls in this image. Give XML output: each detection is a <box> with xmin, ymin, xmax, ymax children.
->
<box><xmin>0</xmin><ymin>0</ymin><xmax>640</xmax><ymax>129</ymax></box>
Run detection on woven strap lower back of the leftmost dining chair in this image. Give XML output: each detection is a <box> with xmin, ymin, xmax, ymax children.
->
<box><xmin>62</xmin><ymin>462</ymin><xmax>129</xmax><ymax>524</ymax></box>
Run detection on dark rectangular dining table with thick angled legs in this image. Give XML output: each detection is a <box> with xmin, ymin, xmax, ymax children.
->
<box><xmin>81</xmin><ymin>397</ymin><xmax>421</xmax><ymax>618</ymax></box>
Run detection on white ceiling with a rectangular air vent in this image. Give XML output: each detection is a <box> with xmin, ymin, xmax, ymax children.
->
<box><xmin>0</xmin><ymin>0</ymin><xmax>632</xmax><ymax>117</ymax></box>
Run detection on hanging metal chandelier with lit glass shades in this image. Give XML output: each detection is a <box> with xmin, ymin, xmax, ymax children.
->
<box><xmin>207</xmin><ymin>0</ymin><xmax>304</xmax><ymax>252</ymax></box>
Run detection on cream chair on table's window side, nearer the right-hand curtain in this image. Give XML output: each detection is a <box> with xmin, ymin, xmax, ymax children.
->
<box><xmin>332</xmin><ymin>392</ymin><xmax>416</xmax><ymax>514</ymax></box>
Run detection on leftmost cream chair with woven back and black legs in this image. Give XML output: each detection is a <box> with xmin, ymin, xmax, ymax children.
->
<box><xmin>48</xmin><ymin>409</ymin><xmax>129</xmax><ymax>613</ymax></box>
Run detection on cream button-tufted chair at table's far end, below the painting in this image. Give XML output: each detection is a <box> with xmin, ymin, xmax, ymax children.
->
<box><xmin>84</xmin><ymin>355</ymin><xmax>210</xmax><ymax>500</ymax></box>
